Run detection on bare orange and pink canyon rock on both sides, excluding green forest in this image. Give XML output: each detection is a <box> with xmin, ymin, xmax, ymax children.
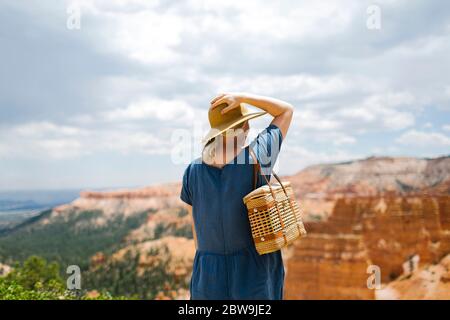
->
<box><xmin>1</xmin><ymin>156</ymin><xmax>450</xmax><ymax>299</ymax></box>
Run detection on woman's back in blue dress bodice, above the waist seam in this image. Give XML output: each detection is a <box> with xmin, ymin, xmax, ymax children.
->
<box><xmin>188</xmin><ymin>147</ymin><xmax>253</xmax><ymax>254</ymax></box>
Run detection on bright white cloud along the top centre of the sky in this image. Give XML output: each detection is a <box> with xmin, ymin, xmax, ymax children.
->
<box><xmin>82</xmin><ymin>0</ymin><xmax>360</xmax><ymax>65</ymax></box>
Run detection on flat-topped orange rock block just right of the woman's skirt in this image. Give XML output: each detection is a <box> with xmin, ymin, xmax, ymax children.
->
<box><xmin>285</xmin><ymin>233</ymin><xmax>374</xmax><ymax>300</ymax></box>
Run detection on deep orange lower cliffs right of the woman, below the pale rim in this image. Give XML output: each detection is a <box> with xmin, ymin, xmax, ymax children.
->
<box><xmin>286</xmin><ymin>196</ymin><xmax>450</xmax><ymax>299</ymax></box>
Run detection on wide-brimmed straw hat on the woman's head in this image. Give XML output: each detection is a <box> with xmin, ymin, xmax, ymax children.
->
<box><xmin>202</xmin><ymin>103</ymin><xmax>267</xmax><ymax>145</ymax></box>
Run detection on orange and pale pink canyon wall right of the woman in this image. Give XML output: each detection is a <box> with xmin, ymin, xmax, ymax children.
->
<box><xmin>285</xmin><ymin>157</ymin><xmax>450</xmax><ymax>299</ymax></box>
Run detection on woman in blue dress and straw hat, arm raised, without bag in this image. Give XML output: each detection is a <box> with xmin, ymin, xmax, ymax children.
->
<box><xmin>180</xmin><ymin>93</ymin><xmax>293</xmax><ymax>300</ymax></box>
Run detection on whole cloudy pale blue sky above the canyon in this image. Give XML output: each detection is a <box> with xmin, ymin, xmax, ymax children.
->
<box><xmin>0</xmin><ymin>0</ymin><xmax>450</xmax><ymax>190</ymax></box>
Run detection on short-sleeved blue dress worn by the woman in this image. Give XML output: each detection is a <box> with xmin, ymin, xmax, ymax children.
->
<box><xmin>180</xmin><ymin>124</ymin><xmax>284</xmax><ymax>300</ymax></box>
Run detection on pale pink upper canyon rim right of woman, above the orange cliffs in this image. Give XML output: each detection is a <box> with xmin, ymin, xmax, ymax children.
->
<box><xmin>287</xmin><ymin>157</ymin><xmax>450</xmax><ymax>219</ymax></box>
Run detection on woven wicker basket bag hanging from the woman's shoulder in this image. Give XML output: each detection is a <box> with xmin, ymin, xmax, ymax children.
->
<box><xmin>243</xmin><ymin>150</ymin><xmax>306</xmax><ymax>255</ymax></box>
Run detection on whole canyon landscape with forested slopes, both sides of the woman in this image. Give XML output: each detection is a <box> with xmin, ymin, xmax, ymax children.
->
<box><xmin>0</xmin><ymin>157</ymin><xmax>450</xmax><ymax>299</ymax></box>
